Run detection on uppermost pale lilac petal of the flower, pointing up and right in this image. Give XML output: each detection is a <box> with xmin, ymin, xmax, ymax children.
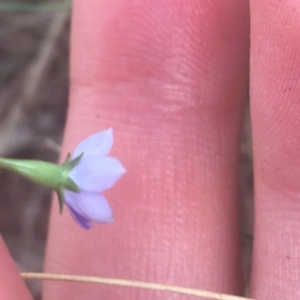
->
<box><xmin>72</xmin><ymin>128</ymin><xmax>114</xmax><ymax>158</ymax></box>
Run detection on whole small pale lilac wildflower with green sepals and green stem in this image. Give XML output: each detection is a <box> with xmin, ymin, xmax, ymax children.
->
<box><xmin>0</xmin><ymin>128</ymin><xmax>126</xmax><ymax>229</ymax></box>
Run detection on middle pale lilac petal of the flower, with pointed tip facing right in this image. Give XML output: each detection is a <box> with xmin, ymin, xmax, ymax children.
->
<box><xmin>69</xmin><ymin>154</ymin><xmax>126</xmax><ymax>192</ymax></box>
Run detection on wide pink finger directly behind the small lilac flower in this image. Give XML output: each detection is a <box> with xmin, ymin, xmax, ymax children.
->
<box><xmin>45</xmin><ymin>0</ymin><xmax>249</xmax><ymax>299</ymax></box>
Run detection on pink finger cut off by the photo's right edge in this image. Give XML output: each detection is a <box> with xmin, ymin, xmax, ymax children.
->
<box><xmin>250</xmin><ymin>0</ymin><xmax>300</xmax><ymax>300</ymax></box>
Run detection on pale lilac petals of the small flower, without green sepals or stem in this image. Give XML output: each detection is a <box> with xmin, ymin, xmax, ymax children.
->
<box><xmin>63</xmin><ymin>128</ymin><xmax>125</xmax><ymax>229</ymax></box>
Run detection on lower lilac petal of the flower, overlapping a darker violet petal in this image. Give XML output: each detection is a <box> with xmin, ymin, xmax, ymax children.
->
<box><xmin>64</xmin><ymin>191</ymin><xmax>113</xmax><ymax>226</ymax></box>
